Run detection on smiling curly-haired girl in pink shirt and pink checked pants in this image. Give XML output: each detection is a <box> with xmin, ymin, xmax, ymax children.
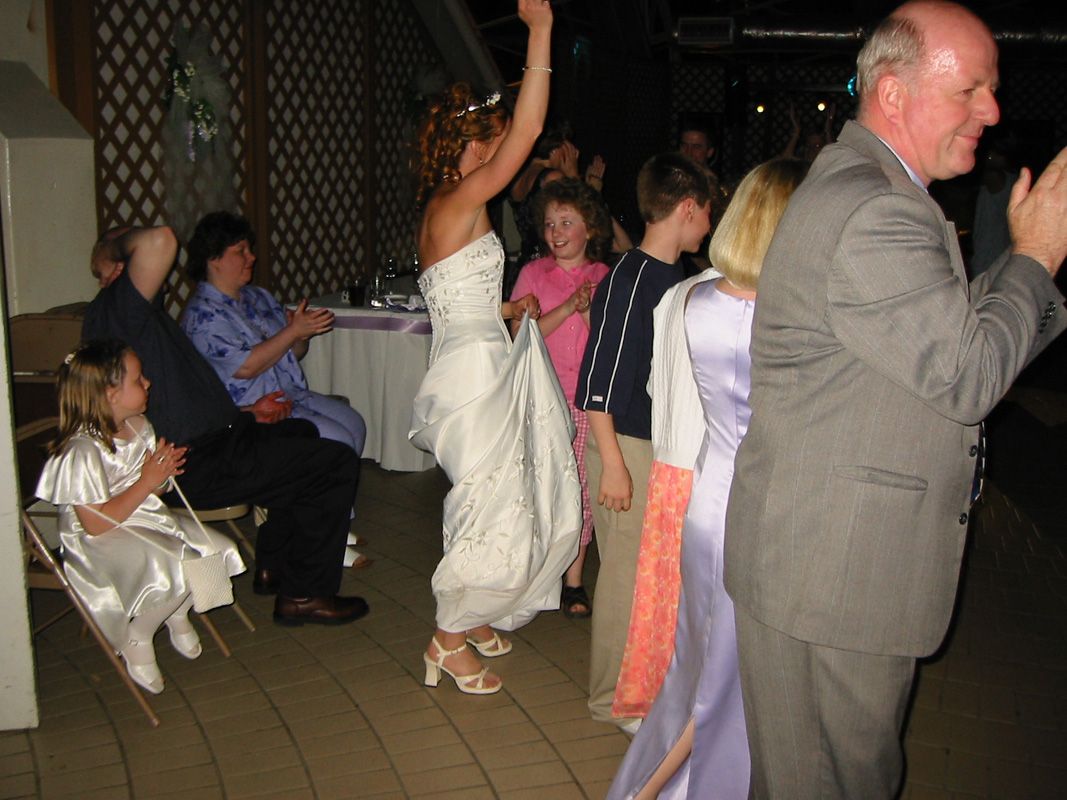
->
<box><xmin>511</xmin><ymin>178</ymin><xmax>611</xmax><ymax>617</ymax></box>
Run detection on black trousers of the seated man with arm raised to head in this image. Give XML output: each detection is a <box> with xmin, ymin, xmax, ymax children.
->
<box><xmin>165</xmin><ymin>413</ymin><xmax>360</xmax><ymax>597</ymax></box>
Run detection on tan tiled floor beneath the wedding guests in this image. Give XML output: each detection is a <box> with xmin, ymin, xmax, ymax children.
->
<box><xmin>0</xmin><ymin>392</ymin><xmax>1067</xmax><ymax>800</ymax></box>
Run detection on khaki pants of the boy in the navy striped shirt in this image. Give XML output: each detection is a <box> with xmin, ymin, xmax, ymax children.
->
<box><xmin>586</xmin><ymin>435</ymin><xmax>652</xmax><ymax>725</ymax></box>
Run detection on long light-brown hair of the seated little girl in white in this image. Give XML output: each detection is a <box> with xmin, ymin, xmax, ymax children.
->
<box><xmin>48</xmin><ymin>339</ymin><xmax>133</xmax><ymax>455</ymax></box>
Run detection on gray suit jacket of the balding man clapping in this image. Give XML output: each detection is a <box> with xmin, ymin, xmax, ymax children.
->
<box><xmin>726</xmin><ymin>123</ymin><xmax>1067</xmax><ymax>656</ymax></box>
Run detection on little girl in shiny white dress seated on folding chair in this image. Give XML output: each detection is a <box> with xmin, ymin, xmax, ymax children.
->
<box><xmin>36</xmin><ymin>340</ymin><xmax>244</xmax><ymax>694</ymax></box>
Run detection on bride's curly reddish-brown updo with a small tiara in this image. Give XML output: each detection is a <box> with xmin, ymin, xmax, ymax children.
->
<box><xmin>411</xmin><ymin>83</ymin><xmax>508</xmax><ymax>208</ymax></box>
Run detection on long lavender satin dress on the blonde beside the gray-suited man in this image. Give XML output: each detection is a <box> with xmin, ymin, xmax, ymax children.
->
<box><xmin>607</xmin><ymin>281</ymin><xmax>755</xmax><ymax>800</ymax></box>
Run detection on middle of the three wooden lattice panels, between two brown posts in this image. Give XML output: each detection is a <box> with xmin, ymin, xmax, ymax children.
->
<box><xmin>267</xmin><ymin>0</ymin><xmax>372</xmax><ymax>299</ymax></box>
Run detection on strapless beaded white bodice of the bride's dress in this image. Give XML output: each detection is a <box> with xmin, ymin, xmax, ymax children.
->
<box><xmin>418</xmin><ymin>230</ymin><xmax>508</xmax><ymax>364</ymax></box>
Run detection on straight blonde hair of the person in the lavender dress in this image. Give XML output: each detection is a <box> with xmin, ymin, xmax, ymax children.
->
<box><xmin>707</xmin><ymin>158</ymin><xmax>809</xmax><ymax>291</ymax></box>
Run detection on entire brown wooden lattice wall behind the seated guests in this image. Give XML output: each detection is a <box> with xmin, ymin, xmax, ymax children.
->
<box><xmin>64</xmin><ymin>0</ymin><xmax>440</xmax><ymax>314</ymax></box>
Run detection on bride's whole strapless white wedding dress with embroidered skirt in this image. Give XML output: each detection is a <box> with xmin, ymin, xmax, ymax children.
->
<box><xmin>409</xmin><ymin>231</ymin><xmax>582</xmax><ymax>631</ymax></box>
